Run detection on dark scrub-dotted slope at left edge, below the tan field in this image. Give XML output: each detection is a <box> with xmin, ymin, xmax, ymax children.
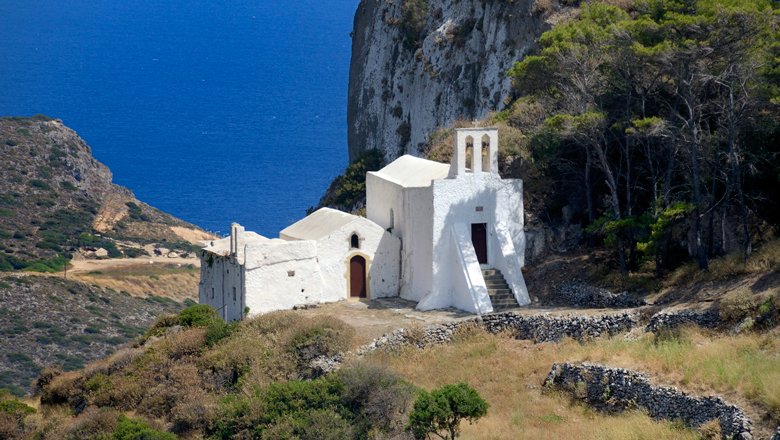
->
<box><xmin>0</xmin><ymin>275</ymin><xmax>182</xmax><ymax>394</ymax></box>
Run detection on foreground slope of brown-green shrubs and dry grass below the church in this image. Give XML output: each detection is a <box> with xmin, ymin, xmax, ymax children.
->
<box><xmin>0</xmin><ymin>306</ymin><xmax>780</xmax><ymax>439</ymax></box>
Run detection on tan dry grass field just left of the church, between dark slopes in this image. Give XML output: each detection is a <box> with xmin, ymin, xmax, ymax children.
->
<box><xmin>72</xmin><ymin>264</ymin><xmax>200</xmax><ymax>301</ymax></box>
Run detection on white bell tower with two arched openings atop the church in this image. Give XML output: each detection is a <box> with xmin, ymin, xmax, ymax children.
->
<box><xmin>449</xmin><ymin>127</ymin><xmax>498</xmax><ymax>178</ymax></box>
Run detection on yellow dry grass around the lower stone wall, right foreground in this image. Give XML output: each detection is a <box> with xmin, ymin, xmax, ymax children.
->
<box><xmin>370</xmin><ymin>324</ymin><xmax>780</xmax><ymax>439</ymax></box>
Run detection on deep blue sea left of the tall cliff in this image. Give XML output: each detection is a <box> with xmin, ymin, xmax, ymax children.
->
<box><xmin>0</xmin><ymin>0</ymin><xmax>358</xmax><ymax>236</ymax></box>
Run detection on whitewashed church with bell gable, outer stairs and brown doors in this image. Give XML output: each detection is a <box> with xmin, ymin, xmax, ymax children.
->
<box><xmin>199</xmin><ymin>128</ymin><xmax>530</xmax><ymax>321</ymax></box>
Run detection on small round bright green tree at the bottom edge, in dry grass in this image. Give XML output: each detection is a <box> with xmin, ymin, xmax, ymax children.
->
<box><xmin>407</xmin><ymin>382</ymin><xmax>488</xmax><ymax>439</ymax></box>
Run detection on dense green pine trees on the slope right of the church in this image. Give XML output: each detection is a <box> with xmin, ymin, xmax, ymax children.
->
<box><xmin>428</xmin><ymin>0</ymin><xmax>780</xmax><ymax>286</ymax></box>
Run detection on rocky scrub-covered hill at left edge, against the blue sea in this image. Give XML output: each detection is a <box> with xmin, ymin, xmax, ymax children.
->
<box><xmin>0</xmin><ymin>116</ymin><xmax>209</xmax><ymax>272</ymax></box>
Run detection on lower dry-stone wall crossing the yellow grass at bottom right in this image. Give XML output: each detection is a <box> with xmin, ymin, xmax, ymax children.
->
<box><xmin>545</xmin><ymin>363</ymin><xmax>753</xmax><ymax>440</ymax></box>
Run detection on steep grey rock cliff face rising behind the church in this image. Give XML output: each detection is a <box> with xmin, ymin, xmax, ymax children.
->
<box><xmin>347</xmin><ymin>0</ymin><xmax>547</xmax><ymax>160</ymax></box>
